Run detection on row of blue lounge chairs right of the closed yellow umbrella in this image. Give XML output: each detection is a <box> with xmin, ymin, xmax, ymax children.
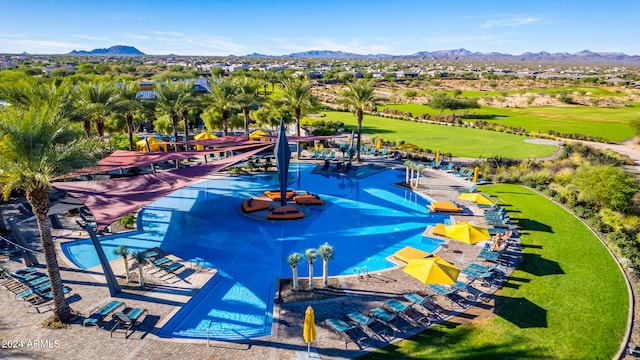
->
<box><xmin>325</xmin><ymin>293</ymin><xmax>438</xmax><ymax>348</ymax></box>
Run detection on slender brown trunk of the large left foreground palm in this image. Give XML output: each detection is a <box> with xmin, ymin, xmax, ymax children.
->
<box><xmin>26</xmin><ymin>189</ymin><xmax>72</xmax><ymax>323</ymax></box>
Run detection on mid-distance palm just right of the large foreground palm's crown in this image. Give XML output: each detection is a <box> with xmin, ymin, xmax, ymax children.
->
<box><xmin>76</xmin><ymin>82</ymin><xmax>119</xmax><ymax>137</ymax></box>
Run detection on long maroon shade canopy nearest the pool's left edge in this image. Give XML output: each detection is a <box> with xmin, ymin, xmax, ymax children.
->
<box><xmin>52</xmin><ymin>143</ymin><xmax>273</xmax><ymax>228</ymax></box>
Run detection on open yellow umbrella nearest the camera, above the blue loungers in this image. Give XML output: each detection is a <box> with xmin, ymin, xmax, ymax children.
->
<box><xmin>402</xmin><ymin>256</ymin><xmax>460</xmax><ymax>284</ymax></box>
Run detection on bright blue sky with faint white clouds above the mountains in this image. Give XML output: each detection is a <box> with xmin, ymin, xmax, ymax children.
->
<box><xmin>0</xmin><ymin>0</ymin><xmax>640</xmax><ymax>55</ymax></box>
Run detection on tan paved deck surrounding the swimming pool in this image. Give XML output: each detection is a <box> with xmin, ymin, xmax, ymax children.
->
<box><xmin>0</xmin><ymin>157</ymin><xmax>520</xmax><ymax>360</ymax></box>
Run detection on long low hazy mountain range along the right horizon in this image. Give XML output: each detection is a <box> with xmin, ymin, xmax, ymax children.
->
<box><xmin>278</xmin><ymin>49</ymin><xmax>640</xmax><ymax>65</ymax></box>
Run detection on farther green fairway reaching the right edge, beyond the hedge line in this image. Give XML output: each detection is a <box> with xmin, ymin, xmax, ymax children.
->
<box><xmin>385</xmin><ymin>104</ymin><xmax>638</xmax><ymax>142</ymax></box>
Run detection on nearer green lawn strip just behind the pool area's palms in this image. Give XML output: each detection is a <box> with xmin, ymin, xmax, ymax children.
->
<box><xmin>314</xmin><ymin>111</ymin><xmax>556</xmax><ymax>159</ymax></box>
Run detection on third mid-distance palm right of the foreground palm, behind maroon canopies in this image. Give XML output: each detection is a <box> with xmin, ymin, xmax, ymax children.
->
<box><xmin>155</xmin><ymin>81</ymin><xmax>192</xmax><ymax>147</ymax></box>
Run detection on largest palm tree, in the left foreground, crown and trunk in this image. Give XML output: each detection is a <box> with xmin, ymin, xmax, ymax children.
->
<box><xmin>0</xmin><ymin>98</ymin><xmax>104</xmax><ymax>322</ymax></box>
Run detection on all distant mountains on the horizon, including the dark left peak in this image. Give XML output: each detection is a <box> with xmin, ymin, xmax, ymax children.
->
<box><xmin>63</xmin><ymin>45</ymin><xmax>640</xmax><ymax>65</ymax></box>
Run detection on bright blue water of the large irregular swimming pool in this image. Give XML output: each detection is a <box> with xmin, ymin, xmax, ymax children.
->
<box><xmin>63</xmin><ymin>164</ymin><xmax>448</xmax><ymax>339</ymax></box>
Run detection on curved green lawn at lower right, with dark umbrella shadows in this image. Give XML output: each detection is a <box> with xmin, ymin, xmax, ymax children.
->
<box><xmin>362</xmin><ymin>185</ymin><xmax>629</xmax><ymax>360</ymax></box>
